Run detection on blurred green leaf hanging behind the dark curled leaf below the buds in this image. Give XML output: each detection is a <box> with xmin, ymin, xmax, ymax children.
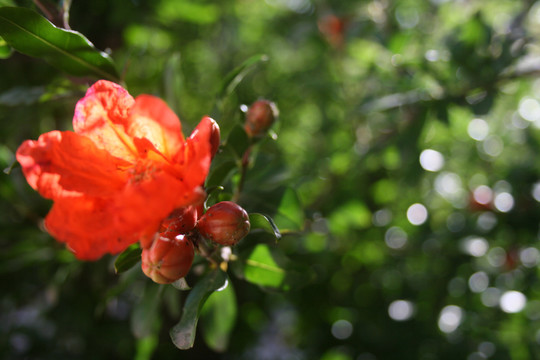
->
<box><xmin>201</xmin><ymin>276</ymin><xmax>237</xmax><ymax>352</ymax></box>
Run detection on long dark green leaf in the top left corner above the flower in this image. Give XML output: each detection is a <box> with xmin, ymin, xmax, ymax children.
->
<box><xmin>0</xmin><ymin>7</ymin><xmax>119</xmax><ymax>82</ymax></box>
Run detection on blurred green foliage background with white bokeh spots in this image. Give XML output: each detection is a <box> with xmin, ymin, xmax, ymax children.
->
<box><xmin>0</xmin><ymin>0</ymin><xmax>540</xmax><ymax>360</ymax></box>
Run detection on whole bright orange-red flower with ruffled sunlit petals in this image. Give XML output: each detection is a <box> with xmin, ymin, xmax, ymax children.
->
<box><xmin>17</xmin><ymin>80</ymin><xmax>215</xmax><ymax>260</ymax></box>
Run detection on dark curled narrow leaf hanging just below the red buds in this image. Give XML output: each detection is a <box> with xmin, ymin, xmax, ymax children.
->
<box><xmin>169</xmin><ymin>270</ymin><xmax>227</xmax><ymax>350</ymax></box>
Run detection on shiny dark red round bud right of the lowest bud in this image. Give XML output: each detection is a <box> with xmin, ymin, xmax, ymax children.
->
<box><xmin>197</xmin><ymin>201</ymin><xmax>250</xmax><ymax>245</ymax></box>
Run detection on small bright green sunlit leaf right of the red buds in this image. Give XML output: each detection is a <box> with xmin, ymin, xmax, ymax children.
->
<box><xmin>244</xmin><ymin>244</ymin><xmax>285</xmax><ymax>288</ymax></box>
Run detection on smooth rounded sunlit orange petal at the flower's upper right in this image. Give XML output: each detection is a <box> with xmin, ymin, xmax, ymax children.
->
<box><xmin>127</xmin><ymin>95</ymin><xmax>184</xmax><ymax>159</ymax></box>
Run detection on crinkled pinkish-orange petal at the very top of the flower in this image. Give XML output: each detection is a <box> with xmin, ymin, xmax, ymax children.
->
<box><xmin>73</xmin><ymin>80</ymin><xmax>137</xmax><ymax>161</ymax></box>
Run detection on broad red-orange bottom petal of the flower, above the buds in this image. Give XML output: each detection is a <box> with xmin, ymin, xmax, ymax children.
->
<box><xmin>45</xmin><ymin>170</ymin><xmax>204</xmax><ymax>260</ymax></box>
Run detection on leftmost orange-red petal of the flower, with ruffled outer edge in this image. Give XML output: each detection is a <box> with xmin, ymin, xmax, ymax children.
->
<box><xmin>16</xmin><ymin>131</ymin><xmax>129</xmax><ymax>199</ymax></box>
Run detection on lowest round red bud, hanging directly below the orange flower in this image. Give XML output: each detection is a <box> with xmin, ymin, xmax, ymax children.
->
<box><xmin>141</xmin><ymin>231</ymin><xmax>195</xmax><ymax>284</ymax></box>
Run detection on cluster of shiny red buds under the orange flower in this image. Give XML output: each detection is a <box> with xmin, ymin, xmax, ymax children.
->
<box><xmin>141</xmin><ymin>201</ymin><xmax>250</xmax><ymax>284</ymax></box>
